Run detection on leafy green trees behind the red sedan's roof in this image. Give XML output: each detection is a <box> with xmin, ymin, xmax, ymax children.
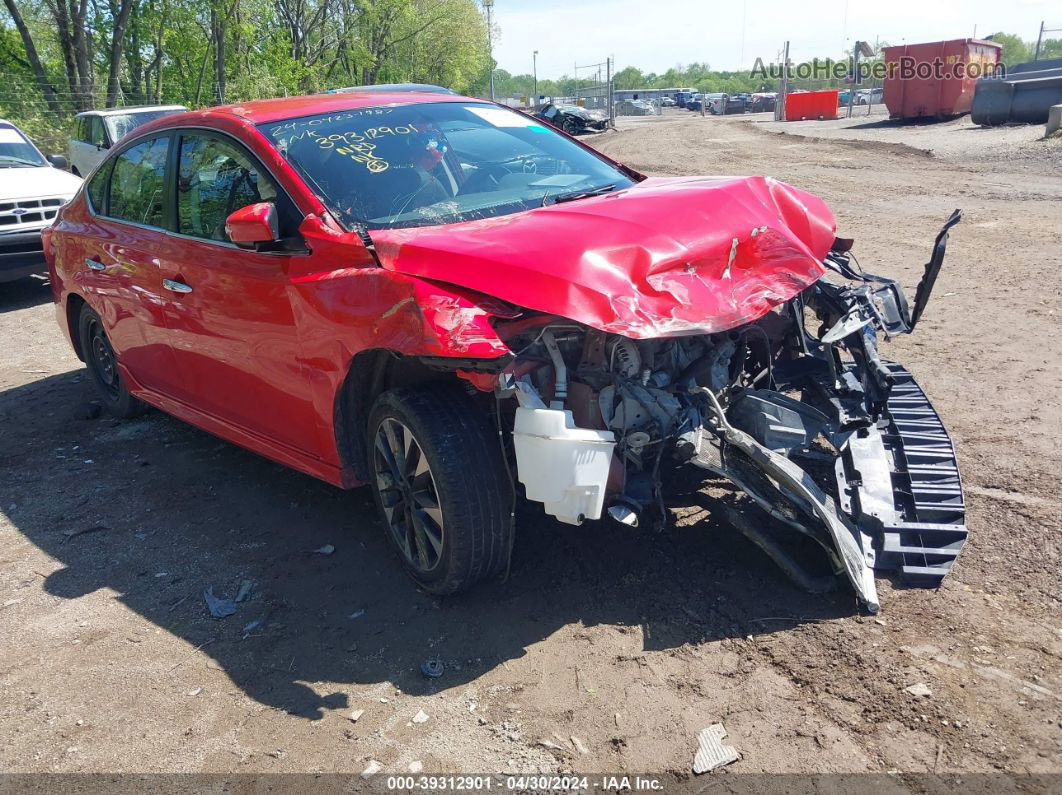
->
<box><xmin>0</xmin><ymin>0</ymin><xmax>491</xmax><ymax>144</ymax></box>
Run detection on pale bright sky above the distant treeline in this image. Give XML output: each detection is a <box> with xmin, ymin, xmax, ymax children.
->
<box><xmin>494</xmin><ymin>0</ymin><xmax>1062</xmax><ymax>77</ymax></box>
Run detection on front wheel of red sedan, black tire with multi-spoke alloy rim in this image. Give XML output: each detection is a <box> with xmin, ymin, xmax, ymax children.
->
<box><xmin>366</xmin><ymin>384</ymin><xmax>513</xmax><ymax>594</ymax></box>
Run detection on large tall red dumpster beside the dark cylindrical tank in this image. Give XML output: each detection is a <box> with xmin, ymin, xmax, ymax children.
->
<box><xmin>883</xmin><ymin>38</ymin><xmax>1001</xmax><ymax>119</ymax></box>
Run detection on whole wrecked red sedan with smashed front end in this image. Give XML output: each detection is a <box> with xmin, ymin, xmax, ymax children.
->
<box><xmin>46</xmin><ymin>91</ymin><xmax>965</xmax><ymax>609</ymax></box>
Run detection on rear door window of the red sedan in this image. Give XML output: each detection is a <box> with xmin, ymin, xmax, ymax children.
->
<box><xmin>107</xmin><ymin>135</ymin><xmax>170</xmax><ymax>227</ymax></box>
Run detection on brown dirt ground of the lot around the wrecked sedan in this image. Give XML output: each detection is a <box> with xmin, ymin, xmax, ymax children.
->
<box><xmin>0</xmin><ymin>111</ymin><xmax>1062</xmax><ymax>776</ymax></box>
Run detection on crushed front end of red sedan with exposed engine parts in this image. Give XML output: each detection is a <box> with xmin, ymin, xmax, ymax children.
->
<box><xmin>497</xmin><ymin>211</ymin><xmax>966</xmax><ymax>612</ymax></box>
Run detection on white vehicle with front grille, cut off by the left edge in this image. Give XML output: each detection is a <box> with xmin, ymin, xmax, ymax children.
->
<box><xmin>0</xmin><ymin>119</ymin><xmax>81</xmax><ymax>281</ymax></box>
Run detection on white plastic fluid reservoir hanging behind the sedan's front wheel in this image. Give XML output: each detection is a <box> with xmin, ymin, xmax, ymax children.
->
<box><xmin>513</xmin><ymin>408</ymin><xmax>616</xmax><ymax>524</ymax></box>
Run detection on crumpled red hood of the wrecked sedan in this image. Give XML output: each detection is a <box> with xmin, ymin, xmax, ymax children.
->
<box><xmin>371</xmin><ymin>177</ymin><xmax>835</xmax><ymax>339</ymax></box>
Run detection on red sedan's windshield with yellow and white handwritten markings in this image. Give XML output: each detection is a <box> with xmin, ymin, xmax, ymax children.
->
<box><xmin>259</xmin><ymin>102</ymin><xmax>633</xmax><ymax>229</ymax></box>
